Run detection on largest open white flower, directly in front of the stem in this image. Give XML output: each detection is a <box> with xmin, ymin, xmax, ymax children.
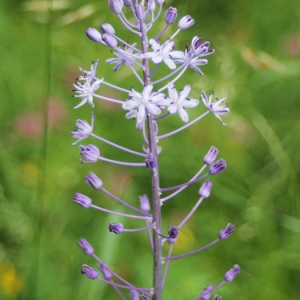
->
<box><xmin>123</xmin><ymin>85</ymin><xmax>168</xmax><ymax>123</ymax></box>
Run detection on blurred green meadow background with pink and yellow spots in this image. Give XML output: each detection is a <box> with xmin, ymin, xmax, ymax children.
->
<box><xmin>0</xmin><ymin>0</ymin><xmax>300</xmax><ymax>300</ymax></box>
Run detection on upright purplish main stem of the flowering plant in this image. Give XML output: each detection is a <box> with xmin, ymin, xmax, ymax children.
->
<box><xmin>140</xmin><ymin>17</ymin><xmax>162</xmax><ymax>300</ymax></box>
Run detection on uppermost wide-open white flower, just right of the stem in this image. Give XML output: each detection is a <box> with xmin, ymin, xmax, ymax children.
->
<box><xmin>143</xmin><ymin>39</ymin><xmax>183</xmax><ymax>69</ymax></box>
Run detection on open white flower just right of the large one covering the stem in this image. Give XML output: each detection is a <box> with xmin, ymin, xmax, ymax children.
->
<box><xmin>168</xmin><ymin>83</ymin><xmax>199</xmax><ymax>122</ymax></box>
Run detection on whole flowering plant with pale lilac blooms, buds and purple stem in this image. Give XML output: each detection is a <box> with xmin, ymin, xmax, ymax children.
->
<box><xmin>71</xmin><ymin>0</ymin><xmax>240</xmax><ymax>300</ymax></box>
